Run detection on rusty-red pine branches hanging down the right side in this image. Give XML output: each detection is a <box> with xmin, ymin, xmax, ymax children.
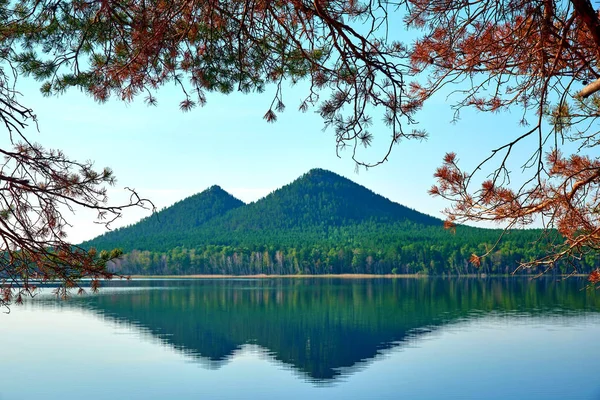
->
<box><xmin>406</xmin><ymin>0</ymin><xmax>600</xmax><ymax>268</ymax></box>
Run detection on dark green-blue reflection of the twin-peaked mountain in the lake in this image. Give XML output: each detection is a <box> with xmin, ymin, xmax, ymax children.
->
<box><xmin>55</xmin><ymin>279</ymin><xmax>600</xmax><ymax>381</ymax></box>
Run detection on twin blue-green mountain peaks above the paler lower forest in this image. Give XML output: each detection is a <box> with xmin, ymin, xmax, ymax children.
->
<box><xmin>82</xmin><ymin>168</ymin><xmax>442</xmax><ymax>251</ymax></box>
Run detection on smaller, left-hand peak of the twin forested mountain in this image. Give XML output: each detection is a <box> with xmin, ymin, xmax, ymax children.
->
<box><xmin>83</xmin><ymin>185</ymin><xmax>244</xmax><ymax>250</ymax></box>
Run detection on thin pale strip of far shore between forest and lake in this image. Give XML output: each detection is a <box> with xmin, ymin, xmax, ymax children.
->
<box><xmin>124</xmin><ymin>274</ymin><xmax>587</xmax><ymax>279</ymax></box>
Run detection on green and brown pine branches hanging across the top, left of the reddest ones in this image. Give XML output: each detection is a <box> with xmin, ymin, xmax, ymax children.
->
<box><xmin>14</xmin><ymin>0</ymin><xmax>424</xmax><ymax>164</ymax></box>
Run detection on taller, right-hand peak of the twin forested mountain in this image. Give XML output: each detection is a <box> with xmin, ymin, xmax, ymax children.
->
<box><xmin>202</xmin><ymin>169</ymin><xmax>442</xmax><ymax>231</ymax></box>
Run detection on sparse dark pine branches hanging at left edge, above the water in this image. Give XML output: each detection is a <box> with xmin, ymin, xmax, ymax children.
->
<box><xmin>0</xmin><ymin>142</ymin><xmax>151</xmax><ymax>306</ymax></box>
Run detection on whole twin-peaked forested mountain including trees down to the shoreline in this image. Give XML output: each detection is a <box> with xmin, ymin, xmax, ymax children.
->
<box><xmin>83</xmin><ymin>169</ymin><xmax>597</xmax><ymax>275</ymax></box>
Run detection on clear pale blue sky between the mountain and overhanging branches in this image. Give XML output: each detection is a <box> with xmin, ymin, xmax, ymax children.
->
<box><xmin>2</xmin><ymin>19</ymin><xmax>556</xmax><ymax>243</ymax></box>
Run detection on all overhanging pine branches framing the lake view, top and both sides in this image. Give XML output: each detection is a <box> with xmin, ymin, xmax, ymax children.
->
<box><xmin>0</xmin><ymin>0</ymin><xmax>600</xmax><ymax>301</ymax></box>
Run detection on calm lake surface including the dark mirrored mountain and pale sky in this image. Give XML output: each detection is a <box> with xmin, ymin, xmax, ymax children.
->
<box><xmin>0</xmin><ymin>279</ymin><xmax>600</xmax><ymax>400</ymax></box>
